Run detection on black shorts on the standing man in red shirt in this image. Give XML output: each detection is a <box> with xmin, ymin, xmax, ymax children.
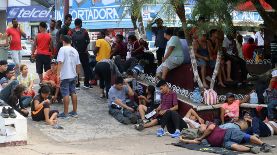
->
<box><xmin>36</xmin><ymin>54</ymin><xmax>51</xmax><ymax>74</ymax></box>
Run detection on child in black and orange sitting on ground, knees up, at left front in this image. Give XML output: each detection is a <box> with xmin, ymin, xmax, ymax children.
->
<box><xmin>31</xmin><ymin>86</ymin><xmax>59</xmax><ymax>125</ymax></box>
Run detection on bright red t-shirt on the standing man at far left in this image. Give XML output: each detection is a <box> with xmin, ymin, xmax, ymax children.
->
<box><xmin>6</xmin><ymin>27</ymin><xmax>22</xmax><ymax>50</ymax></box>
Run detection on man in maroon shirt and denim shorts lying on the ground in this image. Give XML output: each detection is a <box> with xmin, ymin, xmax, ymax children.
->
<box><xmin>180</xmin><ymin>123</ymin><xmax>272</xmax><ymax>154</ymax></box>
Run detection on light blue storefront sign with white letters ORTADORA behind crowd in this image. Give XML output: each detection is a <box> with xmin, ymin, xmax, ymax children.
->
<box><xmin>55</xmin><ymin>0</ymin><xmax>194</xmax><ymax>29</ymax></box>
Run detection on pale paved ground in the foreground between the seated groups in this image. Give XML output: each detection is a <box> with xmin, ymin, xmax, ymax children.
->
<box><xmin>0</xmin><ymin>60</ymin><xmax>277</xmax><ymax>155</ymax></box>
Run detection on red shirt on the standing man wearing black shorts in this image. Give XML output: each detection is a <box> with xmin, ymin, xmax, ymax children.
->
<box><xmin>37</xmin><ymin>33</ymin><xmax>52</xmax><ymax>56</ymax></box>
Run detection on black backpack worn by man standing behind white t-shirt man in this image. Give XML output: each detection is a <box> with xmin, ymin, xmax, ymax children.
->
<box><xmin>72</xmin><ymin>28</ymin><xmax>88</xmax><ymax>53</ymax></box>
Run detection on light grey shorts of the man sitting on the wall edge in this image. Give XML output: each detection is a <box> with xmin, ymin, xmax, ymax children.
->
<box><xmin>156</xmin><ymin>57</ymin><xmax>184</xmax><ymax>73</ymax></box>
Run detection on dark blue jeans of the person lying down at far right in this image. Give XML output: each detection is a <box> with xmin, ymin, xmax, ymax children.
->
<box><xmin>246</xmin><ymin>117</ymin><xmax>271</xmax><ymax>137</ymax></box>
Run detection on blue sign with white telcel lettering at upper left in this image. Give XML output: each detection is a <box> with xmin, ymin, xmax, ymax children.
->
<box><xmin>7</xmin><ymin>6</ymin><xmax>52</xmax><ymax>22</ymax></box>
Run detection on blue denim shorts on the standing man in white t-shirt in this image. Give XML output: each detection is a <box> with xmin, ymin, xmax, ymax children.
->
<box><xmin>60</xmin><ymin>77</ymin><xmax>77</xmax><ymax>97</ymax></box>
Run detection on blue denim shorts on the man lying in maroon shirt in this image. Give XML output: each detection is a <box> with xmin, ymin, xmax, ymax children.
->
<box><xmin>223</xmin><ymin>128</ymin><xmax>250</xmax><ymax>149</ymax></box>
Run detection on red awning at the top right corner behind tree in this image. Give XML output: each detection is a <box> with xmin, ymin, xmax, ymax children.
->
<box><xmin>236</xmin><ymin>0</ymin><xmax>273</xmax><ymax>11</ymax></box>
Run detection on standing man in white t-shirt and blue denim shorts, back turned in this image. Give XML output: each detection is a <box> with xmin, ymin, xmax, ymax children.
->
<box><xmin>57</xmin><ymin>35</ymin><xmax>81</xmax><ymax>118</ymax></box>
